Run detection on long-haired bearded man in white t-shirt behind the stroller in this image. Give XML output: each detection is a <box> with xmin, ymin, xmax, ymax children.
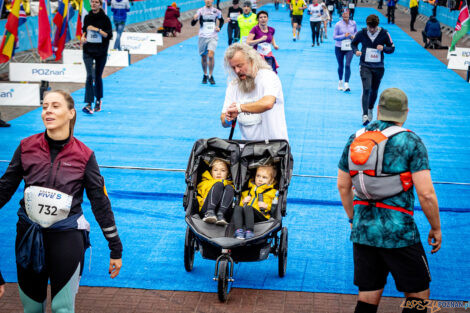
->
<box><xmin>220</xmin><ymin>43</ymin><xmax>288</xmax><ymax>140</ymax></box>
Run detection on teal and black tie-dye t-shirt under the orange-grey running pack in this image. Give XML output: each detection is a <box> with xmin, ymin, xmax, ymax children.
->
<box><xmin>338</xmin><ymin>121</ymin><xmax>430</xmax><ymax>248</ymax></box>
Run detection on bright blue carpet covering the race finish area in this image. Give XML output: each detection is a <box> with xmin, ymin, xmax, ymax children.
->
<box><xmin>0</xmin><ymin>5</ymin><xmax>470</xmax><ymax>300</ymax></box>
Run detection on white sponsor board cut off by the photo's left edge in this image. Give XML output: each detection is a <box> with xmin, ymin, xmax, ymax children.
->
<box><xmin>0</xmin><ymin>84</ymin><xmax>40</xmax><ymax>106</ymax></box>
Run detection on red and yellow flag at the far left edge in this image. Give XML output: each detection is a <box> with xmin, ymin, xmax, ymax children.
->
<box><xmin>0</xmin><ymin>0</ymin><xmax>21</xmax><ymax>63</ymax></box>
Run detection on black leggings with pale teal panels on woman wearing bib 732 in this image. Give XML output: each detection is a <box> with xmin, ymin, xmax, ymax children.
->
<box><xmin>16</xmin><ymin>222</ymin><xmax>85</xmax><ymax>313</ymax></box>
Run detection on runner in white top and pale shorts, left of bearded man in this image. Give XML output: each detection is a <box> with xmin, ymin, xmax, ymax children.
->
<box><xmin>191</xmin><ymin>0</ymin><xmax>224</xmax><ymax>85</ymax></box>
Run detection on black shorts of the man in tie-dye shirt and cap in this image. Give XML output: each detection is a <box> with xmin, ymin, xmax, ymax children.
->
<box><xmin>353</xmin><ymin>243</ymin><xmax>431</xmax><ymax>293</ymax></box>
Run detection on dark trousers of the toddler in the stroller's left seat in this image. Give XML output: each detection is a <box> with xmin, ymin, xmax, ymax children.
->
<box><xmin>201</xmin><ymin>182</ymin><xmax>235</xmax><ymax>217</ymax></box>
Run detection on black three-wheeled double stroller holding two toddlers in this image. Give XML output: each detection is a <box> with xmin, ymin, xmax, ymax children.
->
<box><xmin>183</xmin><ymin>138</ymin><xmax>293</xmax><ymax>302</ymax></box>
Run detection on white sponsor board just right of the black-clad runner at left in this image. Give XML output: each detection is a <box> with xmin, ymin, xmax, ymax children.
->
<box><xmin>109</xmin><ymin>32</ymin><xmax>158</xmax><ymax>54</ymax></box>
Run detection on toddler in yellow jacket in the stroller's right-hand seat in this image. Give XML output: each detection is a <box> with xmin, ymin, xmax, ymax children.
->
<box><xmin>233</xmin><ymin>165</ymin><xmax>277</xmax><ymax>239</ymax></box>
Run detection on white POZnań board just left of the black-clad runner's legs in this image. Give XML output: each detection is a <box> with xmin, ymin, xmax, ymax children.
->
<box><xmin>10</xmin><ymin>62</ymin><xmax>86</xmax><ymax>83</ymax></box>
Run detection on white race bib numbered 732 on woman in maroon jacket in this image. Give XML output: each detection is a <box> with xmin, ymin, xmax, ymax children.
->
<box><xmin>24</xmin><ymin>186</ymin><xmax>73</xmax><ymax>228</ymax></box>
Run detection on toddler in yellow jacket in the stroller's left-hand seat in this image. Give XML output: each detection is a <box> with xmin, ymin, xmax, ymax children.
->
<box><xmin>197</xmin><ymin>159</ymin><xmax>235</xmax><ymax>226</ymax></box>
